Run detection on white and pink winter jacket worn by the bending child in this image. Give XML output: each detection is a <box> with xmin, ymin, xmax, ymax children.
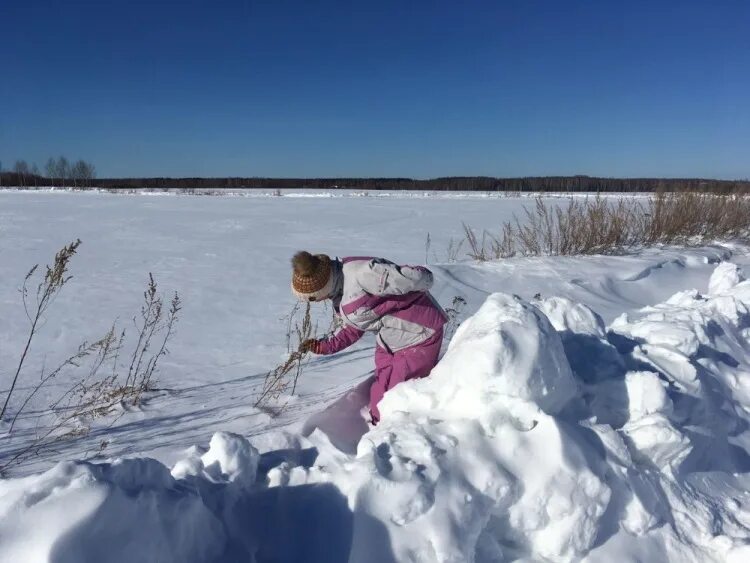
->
<box><xmin>320</xmin><ymin>256</ymin><xmax>447</xmax><ymax>354</ymax></box>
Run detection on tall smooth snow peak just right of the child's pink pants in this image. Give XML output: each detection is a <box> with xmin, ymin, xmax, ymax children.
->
<box><xmin>379</xmin><ymin>293</ymin><xmax>577</xmax><ymax>418</ymax></box>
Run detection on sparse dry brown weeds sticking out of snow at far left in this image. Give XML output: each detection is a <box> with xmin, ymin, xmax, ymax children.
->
<box><xmin>0</xmin><ymin>240</ymin><xmax>181</xmax><ymax>474</ymax></box>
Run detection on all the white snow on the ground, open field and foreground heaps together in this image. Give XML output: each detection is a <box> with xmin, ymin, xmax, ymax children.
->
<box><xmin>0</xmin><ymin>192</ymin><xmax>750</xmax><ymax>563</ymax></box>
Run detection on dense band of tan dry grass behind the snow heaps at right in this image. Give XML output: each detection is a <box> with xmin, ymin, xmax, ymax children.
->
<box><xmin>463</xmin><ymin>192</ymin><xmax>750</xmax><ymax>261</ymax></box>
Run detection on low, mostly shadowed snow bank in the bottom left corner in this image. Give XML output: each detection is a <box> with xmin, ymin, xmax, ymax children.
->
<box><xmin>0</xmin><ymin>433</ymin><xmax>351</xmax><ymax>563</ymax></box>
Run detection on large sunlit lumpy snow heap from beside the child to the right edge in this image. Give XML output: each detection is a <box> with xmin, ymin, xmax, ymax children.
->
<box><xmin>332</xmin><ymin>272</ymin><xmax>750</xmax><ymax>562</ymax></box>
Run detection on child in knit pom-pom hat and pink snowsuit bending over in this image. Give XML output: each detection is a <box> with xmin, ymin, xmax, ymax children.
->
<box><xmin>292</xmin><ymin>251</ymin><xmax>447</xmax><ymax>424</ymax></box>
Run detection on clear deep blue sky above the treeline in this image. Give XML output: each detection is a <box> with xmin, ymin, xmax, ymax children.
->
<box><xmin>0</xmin><ymin>0</ymin><xmax>750</xmax><ymax>178</ymax></box>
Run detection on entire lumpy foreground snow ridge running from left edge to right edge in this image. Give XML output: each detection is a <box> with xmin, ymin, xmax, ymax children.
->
<box><xmin>0</xmin><ymin>264</ymin><xmax>750</xmax><ymax>562</ymax></box>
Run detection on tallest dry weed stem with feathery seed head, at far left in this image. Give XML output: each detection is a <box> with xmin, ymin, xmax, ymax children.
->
<box><xmin>0</xmin><ymin>239</ymin><xmax>81</xmax><ymax>421</ymax></box>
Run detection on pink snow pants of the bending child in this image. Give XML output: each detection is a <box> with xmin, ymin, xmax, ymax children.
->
<box><xmin>370</xmin><ymin>327</ymin><xmax>443</xmax><ymax>424</ymax></box>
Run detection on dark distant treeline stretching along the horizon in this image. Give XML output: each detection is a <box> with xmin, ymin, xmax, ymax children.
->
<box><xmin>0</xmin><ymin>172</ymin><xmax>750</xmax><ymax>193</ymax></box>
